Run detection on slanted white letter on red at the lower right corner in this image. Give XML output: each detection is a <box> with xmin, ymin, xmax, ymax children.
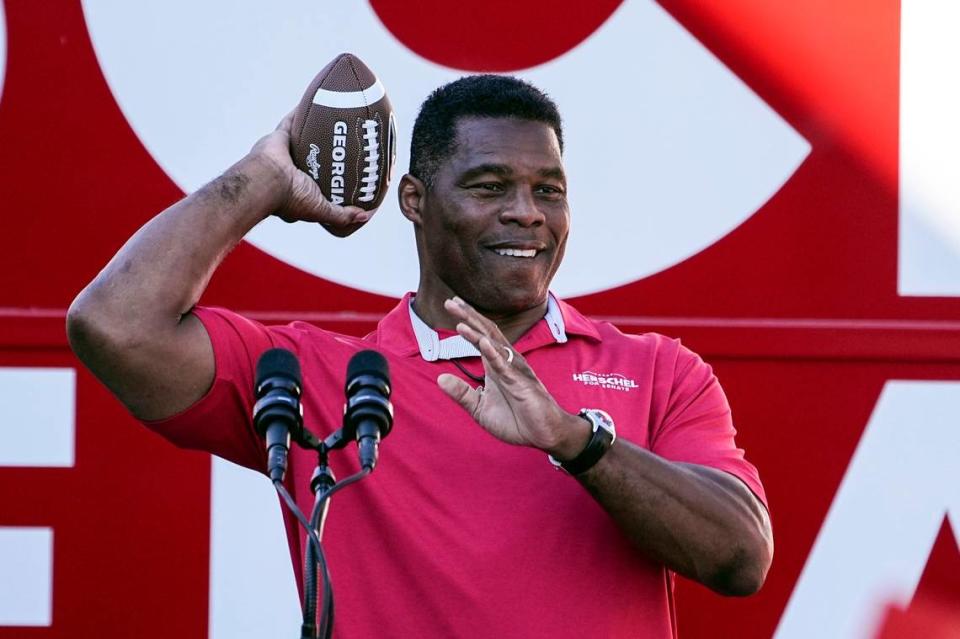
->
<box><xmin>775</xmin><ymin>381</ymin><xmax>960</xmax><ymax>639</ymax></box>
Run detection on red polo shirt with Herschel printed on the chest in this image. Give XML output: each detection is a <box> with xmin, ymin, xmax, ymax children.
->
<box><xmin>147</xmin><ymin>295</ymin><xmax>766</xmax><ymax>639</ymax></box>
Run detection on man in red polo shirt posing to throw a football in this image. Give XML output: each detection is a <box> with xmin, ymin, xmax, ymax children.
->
<box><xmin>68</xmin><ymin>76</ymin><xmax>772</xmax><ymax>637</ymax></box>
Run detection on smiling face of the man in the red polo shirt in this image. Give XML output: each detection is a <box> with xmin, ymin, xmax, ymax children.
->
<box><xmin>420</xmin><ymin>118</ymin><xmax>570</xmax><ymax>314</ymax></box>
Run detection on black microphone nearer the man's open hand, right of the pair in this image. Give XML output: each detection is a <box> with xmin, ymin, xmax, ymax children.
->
<box><xmin>343</xmin><ymin>351</ymin><xmax>393</xmax><ymax>471</ymax></box>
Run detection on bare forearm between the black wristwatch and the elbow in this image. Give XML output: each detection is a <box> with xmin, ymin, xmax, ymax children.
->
<box><xmin>577</xmin><ymin>439</ymin><xmax>773</xmax><ymax>595</ymax></box>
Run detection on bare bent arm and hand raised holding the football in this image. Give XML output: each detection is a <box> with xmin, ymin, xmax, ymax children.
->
<box><xmin>67</xmin><ymin>114</ymin><xmax>369</xmax><ymax>419</ymax></box>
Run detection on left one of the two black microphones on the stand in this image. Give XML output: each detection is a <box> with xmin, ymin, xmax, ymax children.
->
<box><xmin>253</xmin><ymin>348</ymin><xmax>303</xmax><ymax>481</ymax></box>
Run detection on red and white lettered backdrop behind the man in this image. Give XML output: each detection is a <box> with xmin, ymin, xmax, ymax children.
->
<box><xmin>0</xmin><ymin>0</ymin><xmax>960</xmax><ymax>639</ymax></box>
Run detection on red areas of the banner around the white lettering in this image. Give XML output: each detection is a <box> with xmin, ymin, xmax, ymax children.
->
<box><xmin>0</xmin><ymin>0</ymin><xmax>960</xmax><ymax>639</ymax></box>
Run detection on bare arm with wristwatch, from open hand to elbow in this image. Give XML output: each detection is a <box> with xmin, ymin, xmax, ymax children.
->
<box><xmin>437</xmin><ymin>300</ymin><xmax>773</xmax><ymax>595</ymax></box>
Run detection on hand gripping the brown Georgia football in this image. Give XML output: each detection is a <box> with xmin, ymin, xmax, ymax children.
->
<box><xmin>249</xmin><ymin>111</ymin><xmax>373</xmax><ymax>237</ymax></box>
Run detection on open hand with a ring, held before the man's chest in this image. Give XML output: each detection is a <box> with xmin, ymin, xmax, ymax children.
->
<box><xmin>437</xmin><ymin>297</ymin><xmax>590</xmax><ymax>459</ymax></box>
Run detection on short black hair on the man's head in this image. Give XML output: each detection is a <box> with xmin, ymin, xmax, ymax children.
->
<box><xmin>410</xmin><ymin>74</ymin><xmax>563</xmax><ymax>187</ymax></box>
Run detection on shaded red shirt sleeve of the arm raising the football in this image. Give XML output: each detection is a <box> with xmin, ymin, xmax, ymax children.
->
<box><xmin>143</xmin><ymin>307</ymin><xmax>297</xmax><ymax>472</ymax></box>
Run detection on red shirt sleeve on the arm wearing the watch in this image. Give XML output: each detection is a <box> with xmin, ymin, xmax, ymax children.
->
<box><xmin>651</xmin><ymin>344</ymin><xmax>767</xmax><ymax>506</ymax></box>
